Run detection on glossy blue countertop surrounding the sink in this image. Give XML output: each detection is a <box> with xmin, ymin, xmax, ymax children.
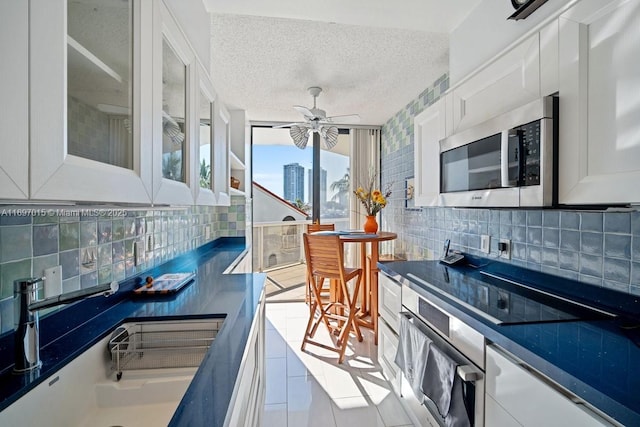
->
<box><xmin>0</xmin><ymin>238</ymin><xmax>265</xmax><ymax>426</ymax></box>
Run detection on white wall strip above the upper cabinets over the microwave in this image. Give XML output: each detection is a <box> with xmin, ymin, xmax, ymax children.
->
<box><xmin>449</xmin><ymin>0</ymin><xmax>576</xmax><ymax>86</ymax></box>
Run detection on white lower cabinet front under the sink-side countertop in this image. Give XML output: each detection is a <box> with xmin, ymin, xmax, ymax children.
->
<box><xmin>224</xmin><ymin>290</ymin><xmax>266</xmax><ymax>427</ymax></box>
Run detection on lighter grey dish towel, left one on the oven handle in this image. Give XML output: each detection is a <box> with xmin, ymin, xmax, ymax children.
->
<box><xmin>394</xmin><ymin>315</ymin><xmax>432</xmax><ymax>403</ymax></box>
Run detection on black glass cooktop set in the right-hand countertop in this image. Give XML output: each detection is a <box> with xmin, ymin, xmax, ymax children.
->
<box><xmin>408</xmin><ymin>264</ymin><xmax>614</xmax><ymax>325</ymax></box>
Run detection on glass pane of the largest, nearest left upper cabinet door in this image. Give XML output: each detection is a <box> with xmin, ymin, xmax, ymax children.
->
<box><xmin>67</xmin><ymin>0</ymin><xmax>133</xmax><ymax>169</ymax></box>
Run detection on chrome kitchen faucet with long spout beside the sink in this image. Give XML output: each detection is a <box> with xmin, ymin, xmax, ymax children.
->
<box><xmin>13</xmin><ymin>277</ymin><xmax>119</xmax><ymax>373</ymax></box>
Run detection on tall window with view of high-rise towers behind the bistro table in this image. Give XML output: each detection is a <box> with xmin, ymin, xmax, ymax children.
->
<box><xmin>251</xmin><ymin>126</ymin><xmax>350</xmax><ymax>270</ymax></box>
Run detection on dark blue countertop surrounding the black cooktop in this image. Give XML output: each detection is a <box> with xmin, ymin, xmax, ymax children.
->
<box><xmin>378</xmin><ymin>261</ymin><xmax>640</xmax><ymax>426</ymax></box>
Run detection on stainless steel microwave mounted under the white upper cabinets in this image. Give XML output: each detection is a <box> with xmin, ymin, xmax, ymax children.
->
<box><xmin>440</xmin><ymin>96</ymin><xmax>558</xmax><ymax>207</ymax></box>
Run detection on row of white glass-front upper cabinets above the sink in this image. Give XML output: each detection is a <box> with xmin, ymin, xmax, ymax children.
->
<box><xmin>12</xmin><ymin>0</ymin><xmax>230</xmax><ymax>205</ymax></box>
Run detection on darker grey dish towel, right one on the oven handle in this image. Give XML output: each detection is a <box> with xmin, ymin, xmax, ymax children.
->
<box><xmin>421</xmin><ymin>345</ymin><xmax>474</xmax><ymax>427</ymax></box>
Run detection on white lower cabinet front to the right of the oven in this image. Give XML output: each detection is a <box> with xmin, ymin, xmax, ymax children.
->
<box><xmin>485</xmin><ymin>344</ymin><xmax>612</xmax><ymax>427</ymax></box>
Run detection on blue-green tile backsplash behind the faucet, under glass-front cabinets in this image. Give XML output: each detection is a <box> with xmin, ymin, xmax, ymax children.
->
<box><xmin>0</xmin><ymin>196</ymin><xmax>247</xmax><ymax>333</ymax></box>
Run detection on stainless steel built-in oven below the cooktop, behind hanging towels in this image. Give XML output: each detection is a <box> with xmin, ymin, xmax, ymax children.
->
<box><xmin>400</xmin><ymin>285</ymin><xmax>485</xmax><ymax>426</ymax></box>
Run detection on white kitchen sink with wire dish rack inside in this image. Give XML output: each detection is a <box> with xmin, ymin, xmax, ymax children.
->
<box><xmin>0</xmin><ymin>318</ymin><xmax>224</xmax><ymax>426</ymax></box>
